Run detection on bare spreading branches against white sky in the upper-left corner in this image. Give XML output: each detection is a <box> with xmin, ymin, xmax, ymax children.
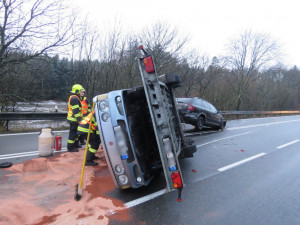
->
<box><xmin>0</xmin><ymin>0</ymin><xmax>76</xmax><ymax>72</ymax></box>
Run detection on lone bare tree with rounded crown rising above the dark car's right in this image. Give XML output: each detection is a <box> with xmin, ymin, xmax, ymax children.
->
<box><xmin>224</xmin><ymin>31</ymin><xmax>280</xmax><ymax>110</ymax></box>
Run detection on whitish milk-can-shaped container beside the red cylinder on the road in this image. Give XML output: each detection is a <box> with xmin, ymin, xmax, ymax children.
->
<box><xmin>39</xmin><ymin>128</ymin><xmax>54</xmax><ymax>157</ymax></box>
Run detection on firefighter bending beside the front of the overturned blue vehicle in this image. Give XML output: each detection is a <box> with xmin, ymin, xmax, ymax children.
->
<box><xmin>78</xmin><ymin>112</ymin><xmax>101</xmax><ymax>166</ymax></box>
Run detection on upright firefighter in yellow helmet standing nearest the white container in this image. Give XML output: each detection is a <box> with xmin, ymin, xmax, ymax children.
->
<box><xmin>67</xmin><ymin>84</ymin><xmax>85</xmax><ymax>152</ymax></box>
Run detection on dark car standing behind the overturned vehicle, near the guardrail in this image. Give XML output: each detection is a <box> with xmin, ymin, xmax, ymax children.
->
<box><xmin>177</xmin><ymin>98</ymin><xmax>226</xmax><ymax>130</ymax></box>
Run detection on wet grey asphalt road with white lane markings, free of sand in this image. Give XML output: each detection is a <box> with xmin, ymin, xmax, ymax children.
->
<box><xmin>0</xmin><ymin>116</ymin><xmax>300</xmax><ymax>225</ymax></box>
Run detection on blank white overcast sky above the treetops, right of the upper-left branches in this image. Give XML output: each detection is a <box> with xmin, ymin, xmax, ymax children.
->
<box><xmin>74</xmin><ymin>0</ymin><xmax>300</xmax><ymax>68</ymax></box>
